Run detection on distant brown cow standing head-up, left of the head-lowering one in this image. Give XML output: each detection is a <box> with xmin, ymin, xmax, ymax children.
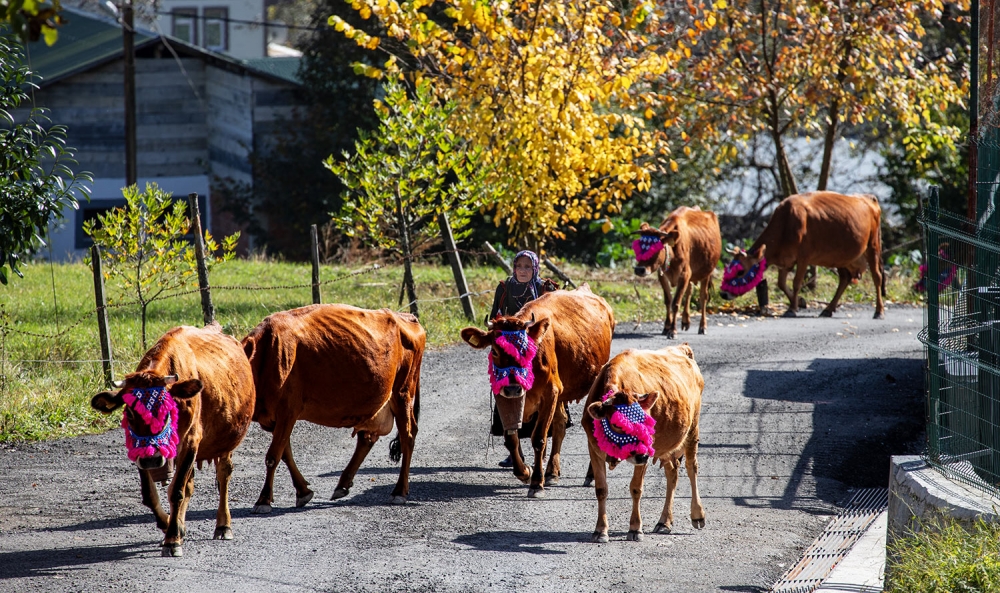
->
<box><xmin>632</xmin><ymin>206</ymin><xmax>722</xmax><ymax>338</ymax></box>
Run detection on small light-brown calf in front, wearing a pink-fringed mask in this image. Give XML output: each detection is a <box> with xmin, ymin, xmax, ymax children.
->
<box><xmin>582</xmin><ymin>344</ymin><xmax>705</xmax><ymax>543</ymax></box>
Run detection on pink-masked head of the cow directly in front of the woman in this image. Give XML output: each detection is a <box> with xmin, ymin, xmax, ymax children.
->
<box><xmin>462</xmin><ymin>313</ymin><xmax>549</xmax><ymax>398</ymax></box>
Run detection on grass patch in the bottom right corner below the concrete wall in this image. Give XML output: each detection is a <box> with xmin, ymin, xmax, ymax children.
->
<box><xmin>885</xmin><ymin>519</ymin><xmax>1000</xmax><ymax>593</ymax></box>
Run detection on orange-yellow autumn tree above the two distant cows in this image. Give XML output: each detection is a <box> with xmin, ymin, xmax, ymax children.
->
<box><xmin>664</xmin><ymin>0</ymin><xmax>968</xmax><ymax>196</ymax></box>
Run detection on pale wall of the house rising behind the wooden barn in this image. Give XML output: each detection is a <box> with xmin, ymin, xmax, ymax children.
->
<box><xmin>155</xmin><ymin>0</ymin><xmax>267</xmax><ymax>59</ymax></box>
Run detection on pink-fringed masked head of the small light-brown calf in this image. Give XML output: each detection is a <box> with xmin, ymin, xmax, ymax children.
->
<box><xmin>587</xmin><ymin>387</ymin><xmax>659</xmax><ymax>465</ymax></box>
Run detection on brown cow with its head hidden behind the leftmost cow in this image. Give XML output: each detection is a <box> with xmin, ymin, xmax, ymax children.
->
<box><xmin>243</xmin><ymin>305</ymin><xmax>426</xmax><ymax>513</ymax></box>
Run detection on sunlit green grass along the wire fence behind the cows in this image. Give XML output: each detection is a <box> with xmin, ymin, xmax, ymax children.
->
<box><xmin>0</xmin><ymin>254</ymin><xmax>917</xmax><ymax>441</ymax></box>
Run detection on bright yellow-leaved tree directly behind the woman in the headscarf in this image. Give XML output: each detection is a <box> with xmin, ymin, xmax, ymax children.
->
<box><xmin>330</xmin><ymin>0</ymin><xmax>715</xmax><ymax>248</ymax></box>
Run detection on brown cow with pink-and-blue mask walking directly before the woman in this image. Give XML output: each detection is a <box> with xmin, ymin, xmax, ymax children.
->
<box><xmin>462</xmin><ymin>284</ymin><xmax>615</xmax><ymax>498</ymax></box>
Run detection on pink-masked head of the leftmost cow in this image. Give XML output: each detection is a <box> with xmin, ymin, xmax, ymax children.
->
<box><xmin>90</xmin><ymin>372</ymin><xmax>202</xmax><ymax>470</ymax></box>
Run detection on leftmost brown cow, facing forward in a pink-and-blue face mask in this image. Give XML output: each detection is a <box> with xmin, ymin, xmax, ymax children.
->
<box><xmin>90</xmin><ymin>323</ymin><xmax>254</xmax><ymax>556</ymax></box>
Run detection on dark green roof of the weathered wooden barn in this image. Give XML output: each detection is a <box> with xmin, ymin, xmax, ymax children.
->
<box><xmin>21</xmin><ymin>8</ymin><xmax>302</xmax><ymax>87</ymax></box>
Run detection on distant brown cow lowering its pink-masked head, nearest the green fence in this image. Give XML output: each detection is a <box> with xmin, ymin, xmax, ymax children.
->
<box><xmin>720</xmin><ymin>191</ymin><xmax>885</xmax><ymax>319</ymax></box>
